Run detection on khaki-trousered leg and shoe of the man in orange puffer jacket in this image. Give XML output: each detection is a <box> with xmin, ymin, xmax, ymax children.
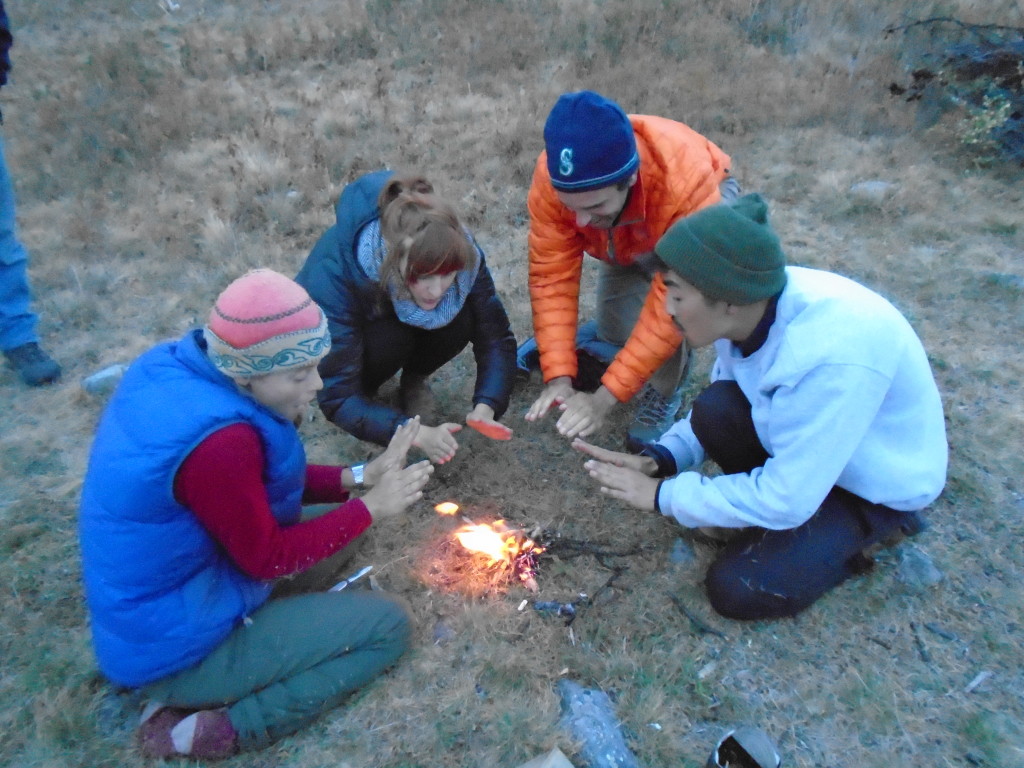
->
<box><xmin>597</xmin><ymin>259</ymin><xmax>690</xmax><ymax>452</ymax></box>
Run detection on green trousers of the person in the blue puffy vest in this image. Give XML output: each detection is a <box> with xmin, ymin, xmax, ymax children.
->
<box><xmin>143</xmin><ymin>590</ymin><xmax>411</xmax><ymax>756</ymax></box>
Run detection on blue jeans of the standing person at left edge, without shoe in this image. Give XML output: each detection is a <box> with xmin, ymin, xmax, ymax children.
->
<box><xmin>0</xmin><ymin>139</ymin><xmax>39</xmax><ymax>350</ymax></box>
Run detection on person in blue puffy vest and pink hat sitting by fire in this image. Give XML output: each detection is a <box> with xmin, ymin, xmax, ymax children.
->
<box><xmin>79</xmin><ymin>269</ymin><xmax>432</xmax><ymax>759</ymax></box>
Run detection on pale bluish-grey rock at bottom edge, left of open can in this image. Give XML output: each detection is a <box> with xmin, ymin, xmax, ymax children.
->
<box><xmin>557</xmin><ymin>678</ymin><xmax>639</xmax><ymax>768</ymax></box>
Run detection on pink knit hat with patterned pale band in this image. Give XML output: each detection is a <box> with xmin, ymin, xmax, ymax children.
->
<box><xmin>203</xmin><ymin>269</ymin><xmax>331</xmax><ymax>379</ymax></box>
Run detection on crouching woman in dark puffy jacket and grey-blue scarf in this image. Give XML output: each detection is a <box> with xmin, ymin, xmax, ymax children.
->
<box><xmin>296</xmin><ymin>171</ymin><xmax>516</xmax><ymax>464</ymax></box>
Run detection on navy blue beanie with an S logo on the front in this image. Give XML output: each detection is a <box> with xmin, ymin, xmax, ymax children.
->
<box><xmin>544</xmin><ymin>91</ymin><xmax>640</xmax><ymax>191</ymax></box>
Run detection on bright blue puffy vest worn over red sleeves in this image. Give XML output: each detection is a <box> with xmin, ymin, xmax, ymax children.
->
<box><xmin>79</xmin><ymin>331</ymin><xmax>306</xmax><ymax>687</ymax></box>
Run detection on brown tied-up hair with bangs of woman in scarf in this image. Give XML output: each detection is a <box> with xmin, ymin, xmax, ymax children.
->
<box><xmin>377</xmin><ymin>174</ymin><xmax>476</xmax><ymax>289</ymax></box>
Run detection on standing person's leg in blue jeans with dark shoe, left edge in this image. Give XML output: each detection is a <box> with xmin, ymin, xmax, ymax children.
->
<box><xmin>0</xmin><ymin>139</ymin><xmax>60</xmax><ymax>385</ymax></box>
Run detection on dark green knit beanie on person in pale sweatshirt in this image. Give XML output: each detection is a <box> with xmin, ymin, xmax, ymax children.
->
<box><xmin>654</xmin><ymin>195</ymin><xmax>785</xmax><ymax>305</ymax></box>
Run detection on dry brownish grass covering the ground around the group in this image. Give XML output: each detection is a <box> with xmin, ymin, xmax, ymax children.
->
<box><xmin>0</xmin><ymin>0</ymin><xmax>1024</xmax><ymax>768</ymax></box>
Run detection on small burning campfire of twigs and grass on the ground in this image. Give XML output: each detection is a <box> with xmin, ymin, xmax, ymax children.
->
<box><xmin>420</xmin><ymin>502</ymin><xmax>544</xmax><ymax>596</ymax></box>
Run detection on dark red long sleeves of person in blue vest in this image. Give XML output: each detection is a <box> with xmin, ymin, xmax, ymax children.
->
<box><xmin>174</xmin><ymin>424</ymin><xmax>373</xmax><ymax>579</ymax></box>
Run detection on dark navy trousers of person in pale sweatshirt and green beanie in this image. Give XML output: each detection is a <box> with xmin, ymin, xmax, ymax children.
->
<box><xmin>690</xmin><ymin>381</ymin><xmax>923</xmax><ymax>620</ymax></box>
